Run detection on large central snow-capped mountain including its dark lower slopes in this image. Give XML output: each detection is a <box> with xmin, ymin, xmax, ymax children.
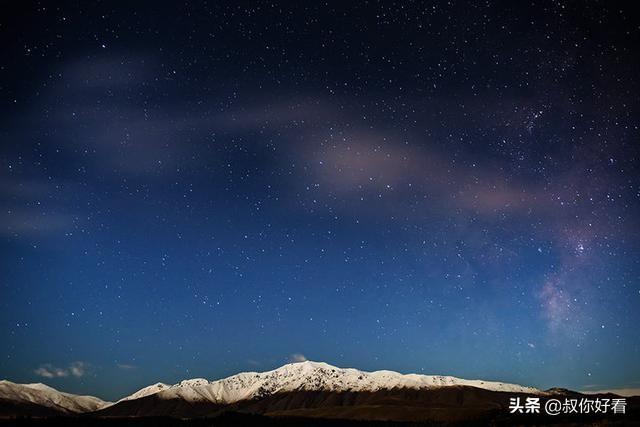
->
<box><xmin>98</xmin><ymin>361</ymin><xmax>544</xmax><ymax>417</ymax></box>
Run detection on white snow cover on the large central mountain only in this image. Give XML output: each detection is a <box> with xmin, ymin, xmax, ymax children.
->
<box><xmin>123</xmin><ymin>361</ymin><xmax>543</xmax><ymax>404</ymax></box>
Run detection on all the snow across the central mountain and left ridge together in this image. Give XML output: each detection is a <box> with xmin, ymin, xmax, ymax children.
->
<box><xmin>0</xmin><ymin>361</ymin><xmax>544</xmax><ymax>413</ymax></box>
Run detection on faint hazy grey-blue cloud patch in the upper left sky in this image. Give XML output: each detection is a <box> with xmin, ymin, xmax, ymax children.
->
<box><xmin>0</xmin><ymin>54</ymin><xmax>195</xmax><ymax>179</ymax></box>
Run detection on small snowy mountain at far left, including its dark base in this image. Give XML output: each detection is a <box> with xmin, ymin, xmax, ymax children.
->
<box><xmin>0</xmin><ymin>380</ymin><xmax>111</xmax><ymax>417</ymax></box>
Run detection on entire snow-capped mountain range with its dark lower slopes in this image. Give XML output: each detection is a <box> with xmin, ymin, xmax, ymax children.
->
<box><xmin>0</xmin><ymin>361</ymin><xmax>638</xmax><ymax>422</ymax></box>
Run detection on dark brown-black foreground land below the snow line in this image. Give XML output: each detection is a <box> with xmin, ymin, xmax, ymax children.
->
<box><xmin>0</xmin><ymin>386</ymin><xmax>640</xmax><ymax>427</ymax></box>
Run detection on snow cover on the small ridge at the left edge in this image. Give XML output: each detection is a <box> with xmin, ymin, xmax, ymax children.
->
<box><xmin>0</xmin><ymin>380</ymin><xmax>111</xmax><ymax>413</ymax></box>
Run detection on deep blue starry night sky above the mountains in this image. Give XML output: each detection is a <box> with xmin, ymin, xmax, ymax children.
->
<box><xmin>0</xmin><ymin>1</ymin><xmax>640</xmax><ymax>399</ymax></box>
